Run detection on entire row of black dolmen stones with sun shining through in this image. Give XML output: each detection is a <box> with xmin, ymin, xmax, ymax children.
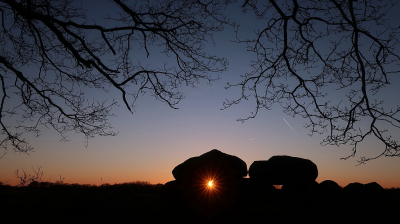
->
<box><xmin>165</xmin><ymin>149</ymin><xmax>385</xmax><ymax>220</ymax></box>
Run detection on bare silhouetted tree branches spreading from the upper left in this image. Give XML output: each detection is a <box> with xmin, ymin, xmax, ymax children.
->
<box><xmin>0</xmin><ymin>0</ymin><xmax>228</xmax><ymax>152</ymax></box>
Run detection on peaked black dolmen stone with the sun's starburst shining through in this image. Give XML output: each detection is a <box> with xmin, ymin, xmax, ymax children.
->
<box><xmin>168</xmin><ymin>149</ymin><xmax>247</xmax><ymax>215</ymax></box>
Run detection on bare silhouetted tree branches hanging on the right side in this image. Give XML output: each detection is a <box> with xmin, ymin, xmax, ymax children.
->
<box><xmin>224</xmin><ymin>0</ymin><xmax>400</xmax><ymax>163</ymax></box>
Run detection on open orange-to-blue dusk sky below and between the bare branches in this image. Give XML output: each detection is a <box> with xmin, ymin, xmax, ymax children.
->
<box><xmin>0</xmin><ymin>0</ymin><xmax>400</xmax><ymax>188</ymax></box>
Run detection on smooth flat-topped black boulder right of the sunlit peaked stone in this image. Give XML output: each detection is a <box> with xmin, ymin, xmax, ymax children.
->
<box><xmin>249</xmin><ymin>156</ymin><xmax>318</xmax><ymax>185</ymax></box>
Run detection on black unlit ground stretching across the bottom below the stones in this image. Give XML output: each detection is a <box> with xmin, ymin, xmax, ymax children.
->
<box><xmin>0</xmin><ymin>183</ymin><xmax>400</xmax><ymax>223</ymax></box>
